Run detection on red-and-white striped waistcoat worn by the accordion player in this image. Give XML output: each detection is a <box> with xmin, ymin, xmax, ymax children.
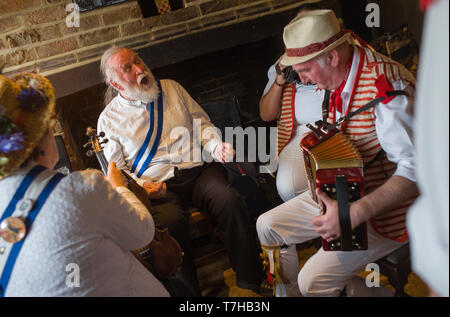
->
<box><xmin>327</xmin><ymin>48</ymin><xmax>415</xmax><ymax>242</ymax></box>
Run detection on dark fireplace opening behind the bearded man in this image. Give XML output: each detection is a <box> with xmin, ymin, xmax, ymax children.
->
<box><xmin>57</xmin><ymin>37</ymin><xmax>283</xmax><ymax>170</ymax></box>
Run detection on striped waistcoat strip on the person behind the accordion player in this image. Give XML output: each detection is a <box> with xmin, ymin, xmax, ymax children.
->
<box><xmin>277</xmin><ymin>84</ymin><xmax>295</xmax><ymax>154</ymax></box>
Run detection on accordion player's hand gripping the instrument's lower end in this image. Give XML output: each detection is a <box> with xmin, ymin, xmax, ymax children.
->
<box><xmin>312</xmin><ymin>188</ymin><xmax>341</xmax><ymax>242</ymax></box>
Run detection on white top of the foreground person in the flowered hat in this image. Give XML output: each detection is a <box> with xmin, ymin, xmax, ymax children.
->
<box><xmin>0</xmin><ymin>165</ymin><xmax>169</xmax><ymax>297</ymax></box>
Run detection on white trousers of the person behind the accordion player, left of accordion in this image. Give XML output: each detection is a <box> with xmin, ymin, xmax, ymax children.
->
<box><xmin>276</xmin><ymin>126</ymin><xmax>308</xmax><ymax>201</ymax></box>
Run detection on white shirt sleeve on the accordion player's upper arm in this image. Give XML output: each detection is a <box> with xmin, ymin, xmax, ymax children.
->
<box><xmin>374</xmin><ymin>80</ymin><xmax>416</xmax><ymax>182</ymax></box>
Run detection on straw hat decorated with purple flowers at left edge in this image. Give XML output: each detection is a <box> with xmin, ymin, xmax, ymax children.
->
<box><xmin>0</xmin><ymin>73</ymin><xmax>55</xmax><ymax>179</ymax></box>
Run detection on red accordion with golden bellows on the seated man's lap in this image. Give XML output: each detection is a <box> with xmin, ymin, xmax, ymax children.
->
<box><xmin>300</xmin><ymin>121</ymin><xmax>367</xmax><ymax>251</ymax></box>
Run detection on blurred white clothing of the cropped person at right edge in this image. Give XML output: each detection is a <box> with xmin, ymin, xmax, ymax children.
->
<box><xmin>407</xmin><ymin>0</ymin><xmax>449</xmax><ymax>296</ymax></box>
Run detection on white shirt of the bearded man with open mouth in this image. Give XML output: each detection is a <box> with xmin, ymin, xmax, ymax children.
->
<box><xmin>97</xmin><ymin>80</ymin><xmax>221</xmax><ymax>185</ymax></box>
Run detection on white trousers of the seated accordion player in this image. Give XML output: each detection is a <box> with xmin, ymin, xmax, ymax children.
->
<box><xmin>256</xmin><ymin>191</ymin><xmax>404</xmax><ymax>296</ymax></box>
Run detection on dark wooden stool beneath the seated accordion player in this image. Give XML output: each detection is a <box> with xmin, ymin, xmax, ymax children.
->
<box><xmin>376</xmin><ymin>243</ymin><xmax>411</xmax><ymax>297</ymax></box>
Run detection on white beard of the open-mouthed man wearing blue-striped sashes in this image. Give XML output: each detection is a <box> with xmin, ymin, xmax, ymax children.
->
<box><xmin>119</xmin><ymin>70</ymin><xmax>159</xmax><ymax>103</ymax></box>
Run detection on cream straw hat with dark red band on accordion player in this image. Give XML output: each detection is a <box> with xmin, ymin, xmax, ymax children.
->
<box><xmin>281</xmin><ymin>10</ymin><xmax>350</xmax><ymax>66</ymax></box>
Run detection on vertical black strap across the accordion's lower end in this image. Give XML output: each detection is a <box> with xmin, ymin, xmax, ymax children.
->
<box><xmin>336</xmin><ymin>175</ymin><xmax>353</xmax><ymax>251</ymax></box>
